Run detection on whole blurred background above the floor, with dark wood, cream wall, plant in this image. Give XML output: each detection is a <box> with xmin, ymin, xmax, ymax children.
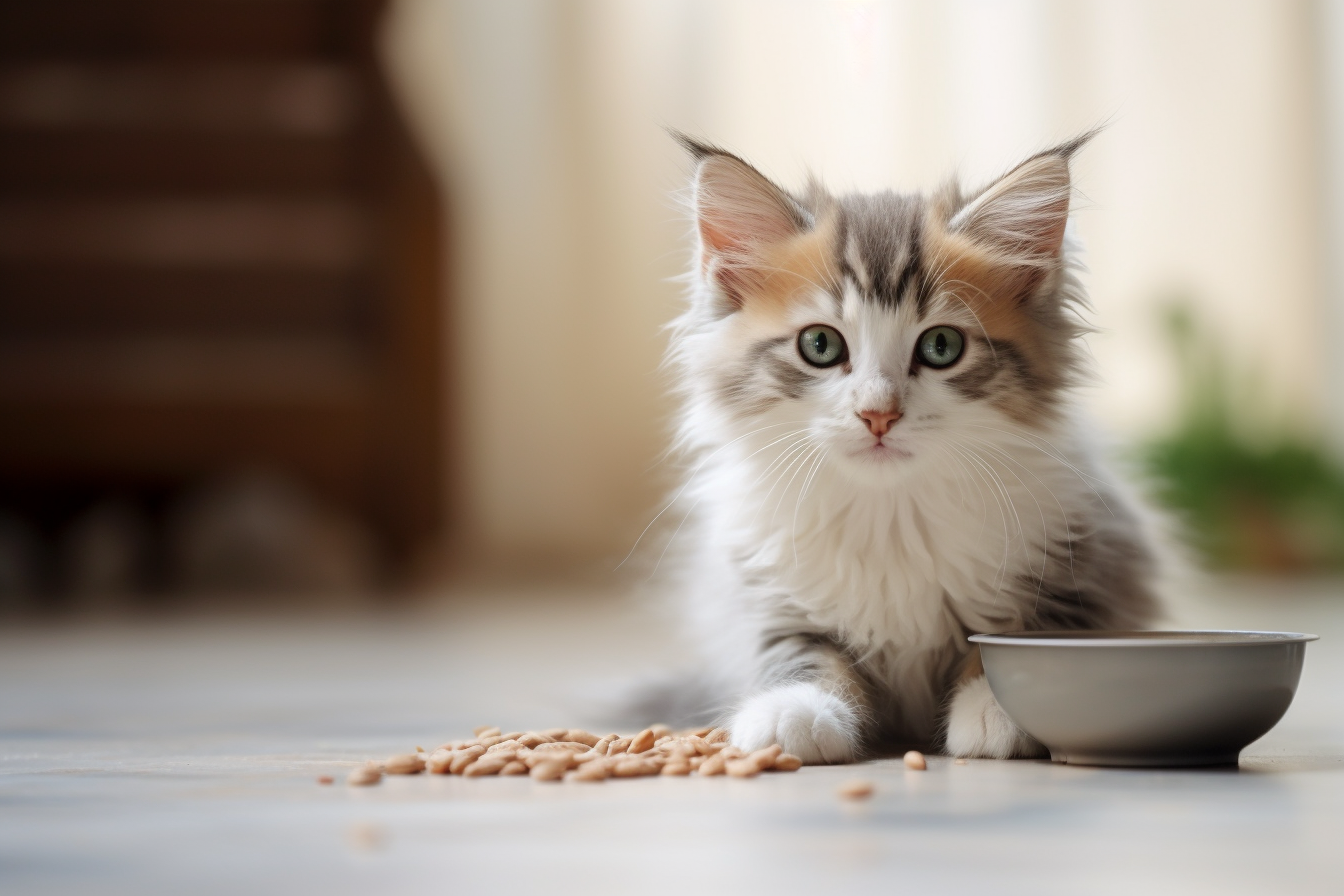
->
<box><xmin>0</xmin><ymin>0</ymin><xmax>1344</xmax><ymax>611</ymax></box>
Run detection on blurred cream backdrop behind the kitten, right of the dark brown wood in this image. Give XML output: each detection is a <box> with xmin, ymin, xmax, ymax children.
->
<box><xmin>386</xmin><ymin>0</ymin><xmax>1327</xmax><ymax>556</ymax></box>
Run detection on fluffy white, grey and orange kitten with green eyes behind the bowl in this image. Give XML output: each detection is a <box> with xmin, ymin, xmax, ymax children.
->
<box><xmin>671</xmin><ymin>134</ymin><xmax>1157</xmax><ymax>763</ymax></box>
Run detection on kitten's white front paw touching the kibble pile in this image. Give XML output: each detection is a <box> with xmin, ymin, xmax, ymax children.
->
<box><xmin>732</xmin><ymin>684</ymin><xmax>859</xmax><ymax>766</ymax></box>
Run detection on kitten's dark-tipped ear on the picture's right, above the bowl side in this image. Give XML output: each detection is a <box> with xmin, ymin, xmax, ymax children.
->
<box><xmin>948</xmin><ymin>132</ymin><xmax>1095</xmax><ymax>267</ymax></box>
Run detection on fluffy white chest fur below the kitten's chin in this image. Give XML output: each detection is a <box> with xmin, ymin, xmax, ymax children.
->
<box><xmin>711</xmin><ymin>427</ymin><xmax>1095</xmax><ymax>666</ymax></box>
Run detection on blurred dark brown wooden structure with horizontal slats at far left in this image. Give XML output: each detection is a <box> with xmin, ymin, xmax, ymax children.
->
<box><xmin>0</xmin><ymin>0</ymin><xmax>445</xmax><ymax>583</ymax></box>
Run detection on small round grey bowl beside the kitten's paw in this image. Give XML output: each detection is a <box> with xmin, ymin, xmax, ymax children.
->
<box><xmin>970</xmin><ymin>631</ymin><xmax>1316</xmax><ymax>766</ymax></box>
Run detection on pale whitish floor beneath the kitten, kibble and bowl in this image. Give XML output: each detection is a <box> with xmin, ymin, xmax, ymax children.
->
<box><xmin>0</xmin><ymin>582</ymin><xmax>1344</xmax><ymax>896</ymax></box>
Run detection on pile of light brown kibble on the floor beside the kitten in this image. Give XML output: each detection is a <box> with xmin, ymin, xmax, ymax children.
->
<box><xmin>347</xmin><ymin>725</ymin><xmax>802</xmax><ymax>786</ymax></box>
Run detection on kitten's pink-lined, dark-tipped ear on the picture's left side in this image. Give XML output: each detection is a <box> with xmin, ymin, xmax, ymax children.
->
<box><xmin>672</xmin><ymin>132</ymin><xmax>812</xmax><ymax>313</ymax></box>
